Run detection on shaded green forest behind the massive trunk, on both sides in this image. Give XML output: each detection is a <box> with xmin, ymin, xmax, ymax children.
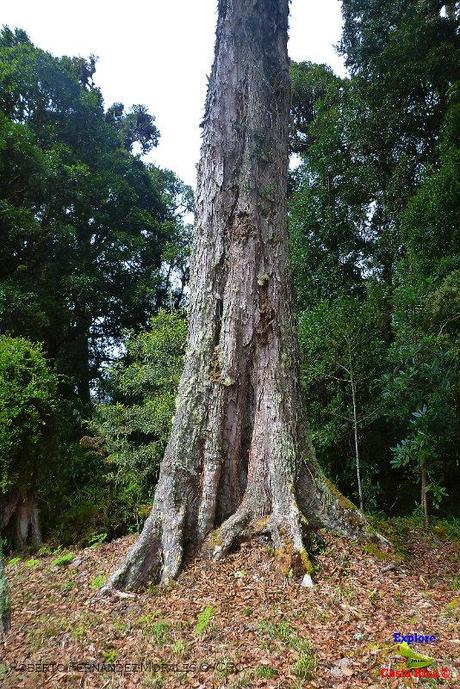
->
<box><xmin>0</xmin><ymin>0</ymin><xmax>460</xmax><ymax>548</ymax></box>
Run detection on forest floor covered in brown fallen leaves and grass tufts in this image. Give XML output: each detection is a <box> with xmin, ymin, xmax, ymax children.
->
<box><xmin>0</xmin><ymin>520</ymin><xmax>460</xmax><ymax>689</ymax></box>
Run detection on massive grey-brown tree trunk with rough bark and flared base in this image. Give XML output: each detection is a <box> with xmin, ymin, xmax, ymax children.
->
<box><xmin>107</xmin><ymin>0</ymin><xmax>366</xmax><ymax>589</ymax></box>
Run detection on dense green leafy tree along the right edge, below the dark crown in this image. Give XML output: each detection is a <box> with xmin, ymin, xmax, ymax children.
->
<box><xmin>385</xmin><ymin>97</ymin><xmax>460</xmax><ymax>524</ymax></box>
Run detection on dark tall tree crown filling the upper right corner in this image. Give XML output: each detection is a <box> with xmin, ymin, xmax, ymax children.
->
<box><xmin>341</xmin><ymin>0</ymin><xmax>460</xmax><ymax>284</ymax></box>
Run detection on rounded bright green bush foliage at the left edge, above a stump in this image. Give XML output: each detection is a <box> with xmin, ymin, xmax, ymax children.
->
<box><xmin>0</xmin><ymin>335</ymin><xmax>58</xmax><ymax>496</ymax></box>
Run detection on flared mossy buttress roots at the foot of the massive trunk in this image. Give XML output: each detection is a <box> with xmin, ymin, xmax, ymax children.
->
<box><xmin>102</xmin><ymin>464</ymin><xmax>372</xmax><ymax>594</ymax></box>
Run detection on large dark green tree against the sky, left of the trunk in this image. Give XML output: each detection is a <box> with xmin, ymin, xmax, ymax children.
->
<box><xmin>0</xmin><ymin>28</ymin><xmax>186</xmax><ymax>413</ymax></box>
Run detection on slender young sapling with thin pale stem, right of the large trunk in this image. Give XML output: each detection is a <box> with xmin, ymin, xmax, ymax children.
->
<box><xmin>300</xmin><ymin>289</ymin><xmax>385</xmax><ymax>510</ymax></box>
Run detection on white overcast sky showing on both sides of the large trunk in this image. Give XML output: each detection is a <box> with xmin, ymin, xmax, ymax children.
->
<box><xmin>0</xmin><ymin>0</ymin><xmax>344</xmax><ymax>185</ymax></box>
